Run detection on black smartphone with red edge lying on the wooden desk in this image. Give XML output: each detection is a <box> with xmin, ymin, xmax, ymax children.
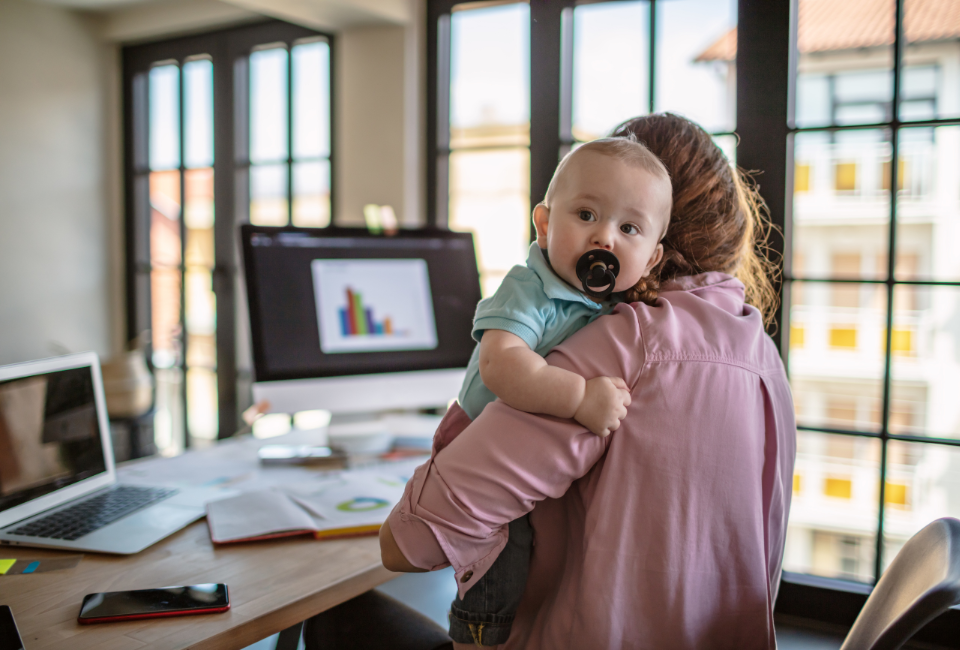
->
<box><xmin>77</xmin><ymin>583</ymin><xmax>230</xmax><ymax>624</ymax></box>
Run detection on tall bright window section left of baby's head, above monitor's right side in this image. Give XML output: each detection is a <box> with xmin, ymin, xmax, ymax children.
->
<box><xmin>443</xmin><ymin>4</ymin><xmax>531</xmax><ymax>295</ymax></box>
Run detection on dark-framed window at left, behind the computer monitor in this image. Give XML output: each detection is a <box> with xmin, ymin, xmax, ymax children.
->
<box><xmin>123</xmin><ymin>21</ymin><xmax>331</xmax><ymax>454</ymax></box>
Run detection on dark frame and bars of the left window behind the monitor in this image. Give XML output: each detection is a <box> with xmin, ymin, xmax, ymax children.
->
<box><xmin>121</xmin><ymin>20</ymin><xmax>336</xmax><ymax>449</ymax></box>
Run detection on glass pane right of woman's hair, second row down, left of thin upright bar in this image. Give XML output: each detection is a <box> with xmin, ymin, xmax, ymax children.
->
<box><xmin>793</xmin><ymin>130</ymin><xmax>891</xmax><ymax>279</ymax></box>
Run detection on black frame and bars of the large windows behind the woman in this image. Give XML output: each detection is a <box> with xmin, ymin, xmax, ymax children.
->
<box><xmin>427</xmin><ymin>0</ymin><xmax>960</xmax><ymax>636</ymax></box>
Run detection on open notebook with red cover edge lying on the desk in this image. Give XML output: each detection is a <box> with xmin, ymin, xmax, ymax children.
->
<box><xmin>207</xmin><ymin>471</ymin><xmax>407</xmax><ymax>544</ymax></box>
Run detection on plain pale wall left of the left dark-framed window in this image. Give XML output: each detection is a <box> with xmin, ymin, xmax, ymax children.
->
<box><xmin>0</xmin><ymin>0</ymin><xmax>122</xmax><ymax>364</ymax></box>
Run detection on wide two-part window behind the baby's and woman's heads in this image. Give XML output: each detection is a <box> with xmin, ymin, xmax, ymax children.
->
<box><xmin>428</xmin><ymin>0</ymin><xmax>736</xmax><ymax>295</ymax></box>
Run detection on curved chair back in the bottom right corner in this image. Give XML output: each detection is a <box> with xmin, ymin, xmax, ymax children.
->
<box><xmin>840</xmin><ymin>517</ymin><xmax>960</xmax><ymax>650</ymax></box>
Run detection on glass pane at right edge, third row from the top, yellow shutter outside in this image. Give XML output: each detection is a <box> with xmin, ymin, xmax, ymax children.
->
<box><xmin>890</xmin><ymin>285</ymin><xmax>960</xmax><ymax>438</ymax></box>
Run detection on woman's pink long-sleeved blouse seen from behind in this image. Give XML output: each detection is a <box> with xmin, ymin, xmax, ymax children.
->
<box><xmin>389</xmin><ymin>273</ymin><xmax>796</xmax><ymax>650</ymax></box>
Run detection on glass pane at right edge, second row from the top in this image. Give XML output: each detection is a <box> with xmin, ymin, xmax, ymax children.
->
<box><xmin>883</xmin><ymin>126</ymin><xmax>960</xmax><ymax>281</ymax></box>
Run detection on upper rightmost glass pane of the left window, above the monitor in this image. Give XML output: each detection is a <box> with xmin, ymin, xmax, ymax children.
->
<box><xmin>293</xmin><ymin>41</ymin><xmax>330</xmax><ymax>158</ymax></box>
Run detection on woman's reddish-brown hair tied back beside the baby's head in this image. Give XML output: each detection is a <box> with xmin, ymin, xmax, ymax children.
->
<box><xmin>613</xmin><ymin>113</ymin><xmax>780</xmax><ymax>324</ymax></box>
